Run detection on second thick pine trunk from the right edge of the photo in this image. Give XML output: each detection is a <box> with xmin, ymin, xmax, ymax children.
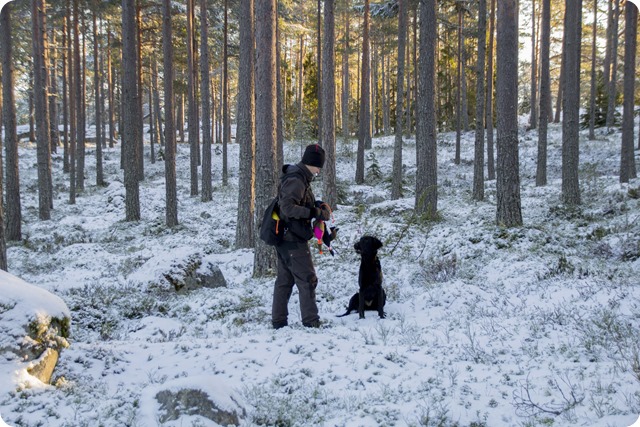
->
<box><xmin>562</xmin><ymin>0</ymin><xmax>582</xmax><ymax>206</ymax></box>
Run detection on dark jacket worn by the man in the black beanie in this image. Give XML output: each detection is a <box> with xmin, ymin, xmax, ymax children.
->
<box><xmin>278</xmin><ymin>163</ymin><xmax>315</xmax><ymax>241</ymax></box>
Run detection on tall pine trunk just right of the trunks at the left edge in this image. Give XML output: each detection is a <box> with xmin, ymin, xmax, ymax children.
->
<box><xmin>31</xmin><ymin>0</ymin><xmax>52</xmax><ymax>220</ymax></box>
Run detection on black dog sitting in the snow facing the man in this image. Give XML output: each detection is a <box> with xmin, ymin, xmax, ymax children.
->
<box><xmin>338</xmin><ymin>236</ymin><xmax>387</xmax><ymax>319</ymax></box>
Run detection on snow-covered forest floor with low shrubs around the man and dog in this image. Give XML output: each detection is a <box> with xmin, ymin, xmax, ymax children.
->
<box><xmin>0</xmin><ymin>121</ymin><xmax>640</xmax><ymax>427</ymax></box>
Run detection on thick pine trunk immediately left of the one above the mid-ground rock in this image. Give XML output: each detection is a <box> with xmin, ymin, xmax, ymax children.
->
<box><xmin>121</xmin><ymin>0</ymin><xmax>140</xmax><ymax>221</ymax></box>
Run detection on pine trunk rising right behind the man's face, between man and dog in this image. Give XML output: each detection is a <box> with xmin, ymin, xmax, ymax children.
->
<box><xmin>321</xmin><ymin>0</ymin><xmax>338</xmax><ymax>210</ymax></box>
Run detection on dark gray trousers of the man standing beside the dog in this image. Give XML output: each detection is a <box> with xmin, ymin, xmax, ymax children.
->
<box><xmin>271</xmin><ymin>241</ymin><xmax>320</xmax><ymax>324</ymax></box>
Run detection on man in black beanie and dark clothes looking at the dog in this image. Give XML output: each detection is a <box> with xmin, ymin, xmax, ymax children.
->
<box><xmin>271</xmin><ymin>144</ymin><xmax>331</xmax><ymax>329</ymax></box>
